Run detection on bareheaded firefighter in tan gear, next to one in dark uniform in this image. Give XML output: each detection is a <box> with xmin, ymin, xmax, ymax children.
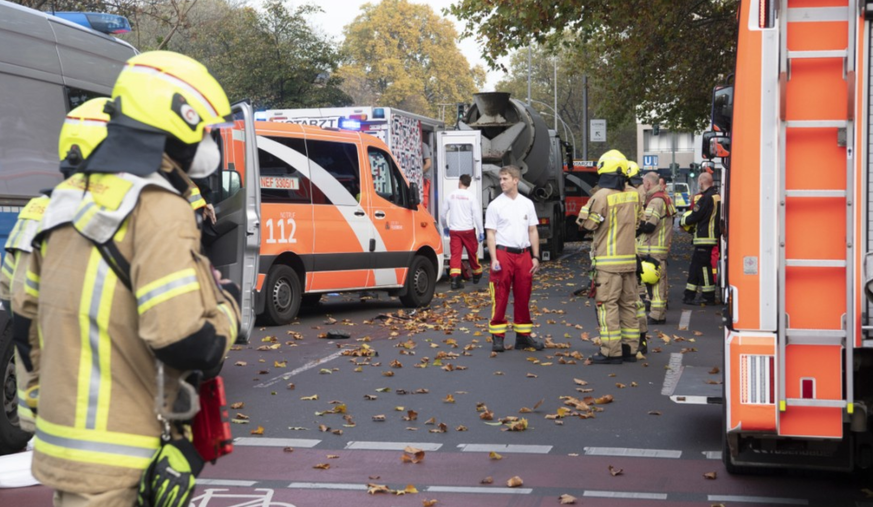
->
<box><xmin>637</xmin><ymin>172</ymin><xmax>676</xmax><ymax>324</ymax></box>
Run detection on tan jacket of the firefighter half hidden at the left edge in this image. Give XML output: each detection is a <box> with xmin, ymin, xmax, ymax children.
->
<box><xmin>0</xmin><ymin>196</ymin><xmax>49</xmax><ymax>432</ymax></box>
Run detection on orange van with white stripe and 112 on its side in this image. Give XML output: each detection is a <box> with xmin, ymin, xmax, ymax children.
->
<box><xmin>212</xmin><ymin>110</ymin><xmax>443</xmax><ymax>324</ymax></box>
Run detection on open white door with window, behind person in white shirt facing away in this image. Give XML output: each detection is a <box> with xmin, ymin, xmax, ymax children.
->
<box><xmin>434</xmin><ymin>130</ymin><xmax>487</xmax><ymax>259</ymax></box>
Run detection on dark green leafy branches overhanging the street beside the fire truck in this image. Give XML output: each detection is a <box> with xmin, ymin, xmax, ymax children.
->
<box><xmin>448</xmin><ymin>0</ymin><xmax>738</xmax><ymax>130</ymax></box>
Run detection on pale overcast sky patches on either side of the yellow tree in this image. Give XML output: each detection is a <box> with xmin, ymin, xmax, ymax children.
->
<box><xmin>304</xmin><ymin>0</ymin><xmax>503</xmax><ymax>91</ymax></box>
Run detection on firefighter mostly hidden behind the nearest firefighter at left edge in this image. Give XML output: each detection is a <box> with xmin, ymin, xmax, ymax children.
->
<box><xmin>0</xmin><ymin>98</ymin><xmax>109</xmax><ymax>433</ymax></box>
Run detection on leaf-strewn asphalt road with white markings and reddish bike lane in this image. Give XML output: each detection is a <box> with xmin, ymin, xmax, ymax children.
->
<box><xmin>0</xmin><ymin>232</ymin><xmax>867</xmax><ymax>507</ymax></box>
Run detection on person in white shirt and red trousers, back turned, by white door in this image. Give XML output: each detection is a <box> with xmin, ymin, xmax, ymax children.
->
<box><xmin>442</xmin><ymin>174</ymin><xmax>485</xmax><ymax>290</ymax></box>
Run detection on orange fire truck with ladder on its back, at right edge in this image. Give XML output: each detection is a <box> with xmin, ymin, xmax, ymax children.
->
<box><xmin>665</xmin><ymin>0</ymin><xmax>873</xmax><ymax>473</ymax></box>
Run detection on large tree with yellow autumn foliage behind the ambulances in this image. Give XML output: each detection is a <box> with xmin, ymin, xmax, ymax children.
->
<box><xmin>337</xmin><ymin>0</ymin><xmax>485</xmax><ymax>117</ymax></box>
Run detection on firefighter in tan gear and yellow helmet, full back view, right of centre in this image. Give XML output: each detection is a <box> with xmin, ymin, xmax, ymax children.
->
<box><xmin>576</xmin><ymin>150</ymin><xmax>640</xmax><ymax>364</ymax></box>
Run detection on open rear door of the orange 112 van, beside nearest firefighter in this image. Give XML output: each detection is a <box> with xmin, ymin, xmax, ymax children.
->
<box><xmin>210</xmin><ymin>103</ymin><xmax>261</xmax><ymax>341</ymax></box>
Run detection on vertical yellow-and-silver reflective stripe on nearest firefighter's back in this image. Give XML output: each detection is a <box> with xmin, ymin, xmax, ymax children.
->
<box><xmin>75</xmin><ymin>248</ymin><xmax>118</xmax><ymax>429</ymax></box>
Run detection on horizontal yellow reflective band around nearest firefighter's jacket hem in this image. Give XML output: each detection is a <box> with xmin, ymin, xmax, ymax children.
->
<box><xmin>34</xmin><ymin>418</ymin><xmax>160</xmax><ymax>470</ymax></box>
